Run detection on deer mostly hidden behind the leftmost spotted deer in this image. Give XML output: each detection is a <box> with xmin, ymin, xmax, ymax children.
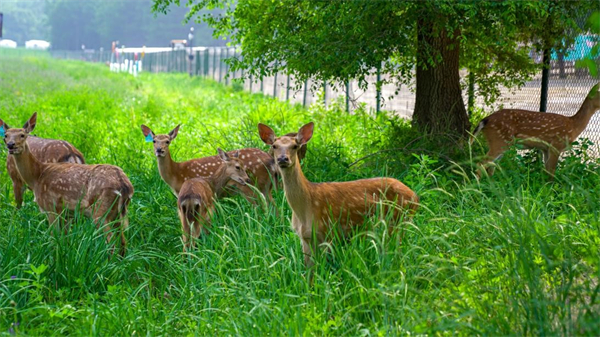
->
<box><xmin>6</xmin><ymin>129</ymin><xmax>85</xmax><ymax>208</ymax></box>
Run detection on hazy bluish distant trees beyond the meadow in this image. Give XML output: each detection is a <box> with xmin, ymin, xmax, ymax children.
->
<box><xmin>41</xmin><ymin>0</ymin><xmax>225</xmax><ymax>50</ymax></box>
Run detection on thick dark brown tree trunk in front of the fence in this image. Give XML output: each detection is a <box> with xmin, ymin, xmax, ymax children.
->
<box><xmin>413</xmin><ymin>20</ymin><xmax>470</xmax><ymax>136</ymax></box>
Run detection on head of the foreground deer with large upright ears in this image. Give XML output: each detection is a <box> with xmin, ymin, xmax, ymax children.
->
<box><xmin>258</xmin><ymin>122</ymin><xmax>315</xmax><ymax>168</ymax></box>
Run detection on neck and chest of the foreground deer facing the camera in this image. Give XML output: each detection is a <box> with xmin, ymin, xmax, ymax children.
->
<box><xmin>279</xmin><ymin>161</ymin><xmax>311</xmax><ymax>217</ymax></box>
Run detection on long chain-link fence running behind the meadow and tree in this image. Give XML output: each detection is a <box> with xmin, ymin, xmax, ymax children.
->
<box><xmin>52</xmin><ymin>28</ymin><xmax>600</xmax><ymax>155</ymax></box>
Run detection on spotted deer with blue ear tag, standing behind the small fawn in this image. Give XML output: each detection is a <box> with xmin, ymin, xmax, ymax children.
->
<box><xmin>142</xmin><ymin>125</ymin><xmax>277</xmax><ymax>202</ymax></box>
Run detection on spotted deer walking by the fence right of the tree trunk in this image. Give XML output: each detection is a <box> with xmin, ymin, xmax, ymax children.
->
<box><xmin>471</xmin><ymin>83</ymin><xmax>600</xmax><ymax>179</ymax></box>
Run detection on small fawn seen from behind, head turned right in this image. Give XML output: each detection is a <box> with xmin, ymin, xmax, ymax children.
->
<box><xmin>177</xmin><ymin>149</ymin><xmax>250</xmax><ymax>252</ymax></box>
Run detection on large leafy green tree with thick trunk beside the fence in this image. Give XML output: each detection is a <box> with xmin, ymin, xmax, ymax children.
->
<box><xmin>153</xmin><ymin>0</ymin><xmax>598</xmax><ymax>135</ymax></box>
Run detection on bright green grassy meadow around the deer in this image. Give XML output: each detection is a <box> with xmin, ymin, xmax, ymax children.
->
<box><xmin>0</xmin><ymin>53</ymin><xmax>600</xmax><ymax>336</ymax></box>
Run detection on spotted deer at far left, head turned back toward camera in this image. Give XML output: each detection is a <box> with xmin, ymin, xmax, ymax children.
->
<box><xmin>0</xmin><ymin>113</ymin><xmax>133</xmax><ymax>256</ymax></box>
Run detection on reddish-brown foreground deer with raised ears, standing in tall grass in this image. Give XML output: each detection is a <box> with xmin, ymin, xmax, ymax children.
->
<box><xmin>258</xmin><ymin>122</ymin><xmax>419</xmax><ymax>267</ymax></box>
